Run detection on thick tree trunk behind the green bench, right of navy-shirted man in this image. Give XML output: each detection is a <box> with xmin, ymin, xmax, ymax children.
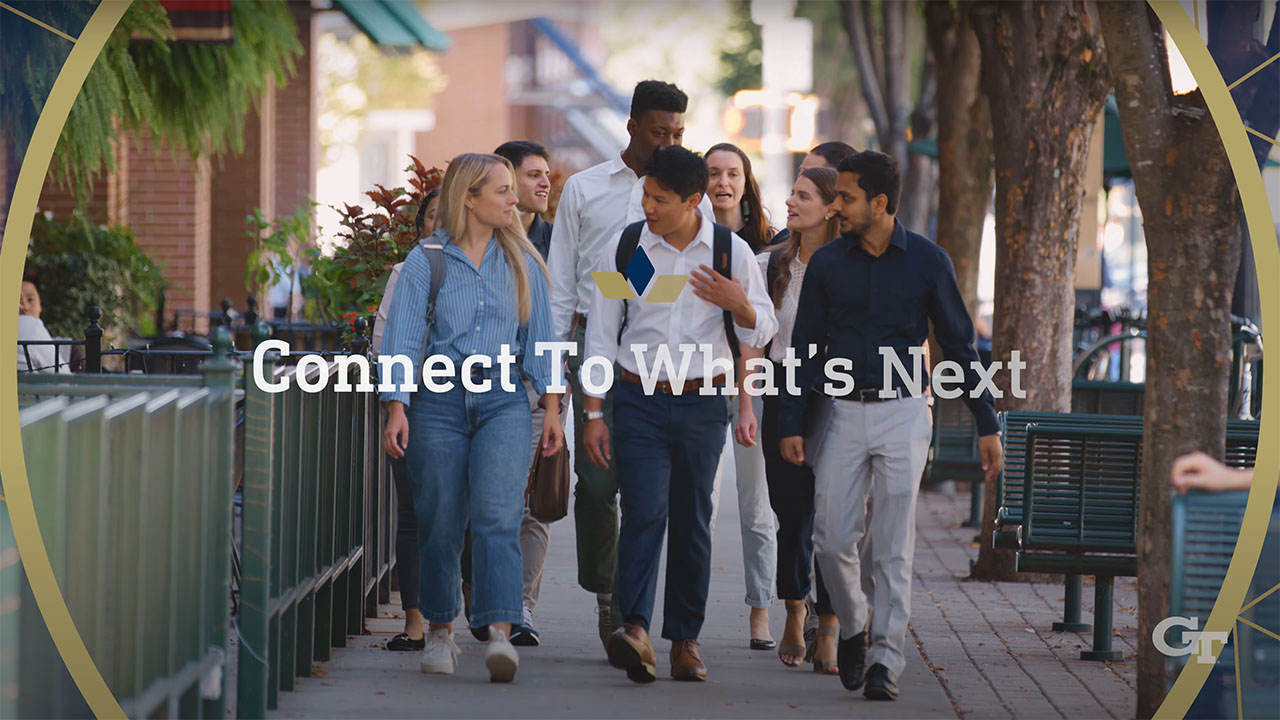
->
<box><xmin>970</xmin><ymin>0</ymin><xmax>1111</xmax><ymax>580</ymax></box>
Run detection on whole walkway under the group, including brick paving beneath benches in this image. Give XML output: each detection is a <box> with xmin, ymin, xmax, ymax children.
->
<box><xmin>270</xmin><ymin>479</ymin><xmax>1137</xmax><ymax>720</ymax></box>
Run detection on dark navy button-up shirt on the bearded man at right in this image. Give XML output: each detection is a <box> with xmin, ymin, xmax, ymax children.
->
<box><xmin>780</xmin><ymin>220</ymin><xmax>1000</xmax><ymax>437</ymax></box>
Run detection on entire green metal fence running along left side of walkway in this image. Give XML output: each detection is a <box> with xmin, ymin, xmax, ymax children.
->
<box><xmin>0</xmin><ymin>331</ymin><xmax>394</xmax><ymax>717</ymax></box>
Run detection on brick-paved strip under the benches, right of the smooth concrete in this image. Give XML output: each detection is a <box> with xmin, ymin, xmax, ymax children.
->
<box><xmin>911</xmin><ymin>484</ymin><xmax>1138</xmax><ymax>720</ymax></box>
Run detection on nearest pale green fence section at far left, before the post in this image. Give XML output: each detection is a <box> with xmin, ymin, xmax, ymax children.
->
<box><xmin>0</xmin><ymin>338</ymin><xmax>236</xmax><ymax>719</ymax></box>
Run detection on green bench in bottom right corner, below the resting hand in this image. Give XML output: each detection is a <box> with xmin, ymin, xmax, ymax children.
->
<box><xmin>1167</xmin><ymin>491</ymin><xmax>1280</xmax><ymax>717</ymax></box>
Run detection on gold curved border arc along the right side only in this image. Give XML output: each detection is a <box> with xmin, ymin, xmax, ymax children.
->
<box><xmin>1138</xmin><ymin>0</ymin><xmax>1280</xmax><ymax>719</ymax></box>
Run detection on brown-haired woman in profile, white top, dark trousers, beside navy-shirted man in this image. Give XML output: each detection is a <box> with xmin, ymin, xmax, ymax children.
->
<box><xmin>735</xmin><ymin>168</ymin><xmax>840</xmax><ymax>675</ymax></box>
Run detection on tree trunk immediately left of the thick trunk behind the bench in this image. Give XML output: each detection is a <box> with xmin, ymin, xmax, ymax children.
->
<box><xmin>924</xmin><ymin>0</ymin><xmax>992</xmax><ymax>314</ymax></box>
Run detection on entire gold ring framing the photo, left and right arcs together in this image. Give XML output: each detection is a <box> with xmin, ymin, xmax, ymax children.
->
<box><xmin>0</xmin><ymin>0</ymin><xmax>1280</xmax><ymax>717</ymax></box>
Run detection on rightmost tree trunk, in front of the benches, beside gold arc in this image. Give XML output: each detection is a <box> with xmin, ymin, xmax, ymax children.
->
<box><xmin>1100</xmin><ymin>3</ymin><xmax>1240</xmax><ymax>717</ymax></box>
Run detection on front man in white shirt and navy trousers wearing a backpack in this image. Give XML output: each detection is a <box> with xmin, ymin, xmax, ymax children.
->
<box><xmin>582</xmin><ymin>147</ymin><xmax>777</xmax><ymax>683</ymax></box>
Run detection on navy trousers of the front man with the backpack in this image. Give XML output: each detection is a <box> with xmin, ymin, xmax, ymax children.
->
<box><xmin>613</xmin><ymin>382</ymin><xmax>728</xmax><ymax>641</ymax></box>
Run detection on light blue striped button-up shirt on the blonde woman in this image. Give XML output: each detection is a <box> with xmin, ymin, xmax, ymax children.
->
<box><xmin>381</xmin><ymin>231</ymin><xmax>554</xmax><ymax>405</ymax></box>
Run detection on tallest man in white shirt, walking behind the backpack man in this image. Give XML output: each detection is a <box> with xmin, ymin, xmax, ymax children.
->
<box><xmin>547</xmin><ymin>79</ymin><xmax>710</xmax><ymax>642</ymax></box>
